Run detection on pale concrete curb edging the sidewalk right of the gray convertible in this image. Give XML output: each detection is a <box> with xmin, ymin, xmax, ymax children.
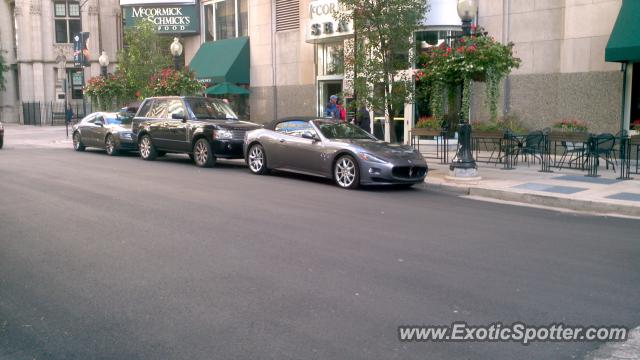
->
<box><xmin>425</xmin><ymin>182</ymin><xmax>640</xmax><ymax>217</ymax></box>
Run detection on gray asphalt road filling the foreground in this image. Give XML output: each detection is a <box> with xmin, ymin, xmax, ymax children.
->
<box><xmin>0</xmin><ymin>146</ymin><xmax>640</xmax><ymax>360</ymax></box>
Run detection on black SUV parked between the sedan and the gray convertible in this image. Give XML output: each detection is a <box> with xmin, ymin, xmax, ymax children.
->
<box><xmin>132</xmin><ymin>96</ymin><xmax>261</xmax><ymax>167</ymax></box>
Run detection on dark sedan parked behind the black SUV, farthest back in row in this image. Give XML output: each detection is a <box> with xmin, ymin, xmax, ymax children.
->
<box><xmin>73</xmin><ymin>112</ymin><xmax>138</xmax><ymax>155</ymax></box>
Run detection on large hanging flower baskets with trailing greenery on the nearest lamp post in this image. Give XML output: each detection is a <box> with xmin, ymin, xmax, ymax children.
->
<box><xmin>415</xmin><ymin>29</ymin><xmax>520</xmax><ymax>120</ymax></box>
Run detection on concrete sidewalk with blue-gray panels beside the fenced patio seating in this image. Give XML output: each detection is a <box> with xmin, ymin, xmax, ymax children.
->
<box><xmin>425</xmin><ymin>159</ymin><xmax>640</xmax><ymax>217</ymax></box>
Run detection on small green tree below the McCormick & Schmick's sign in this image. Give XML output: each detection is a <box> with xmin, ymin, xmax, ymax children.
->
<box><xmin>118</xmin><ymin>21</ymin><xmax>171</xmax><ymax>98</ymax></box>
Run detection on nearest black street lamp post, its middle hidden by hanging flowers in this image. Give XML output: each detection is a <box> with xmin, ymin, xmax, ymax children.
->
<box><xmin>449</xmin><ymin>0</ymin><xmax>478</xmax><ymax>178</ymax></box>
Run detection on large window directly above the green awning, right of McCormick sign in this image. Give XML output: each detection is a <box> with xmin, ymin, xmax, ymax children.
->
<box><xmin>202</xmin><ymin>0</ymin><xmax>249</xmax><ymax>41</ymax></box>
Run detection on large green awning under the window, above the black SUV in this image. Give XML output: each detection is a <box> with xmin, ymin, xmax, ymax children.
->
<box><xmin>189</xmin><ymin>36</ymin><xmax>249</xmax><ymax>84</ymax></box>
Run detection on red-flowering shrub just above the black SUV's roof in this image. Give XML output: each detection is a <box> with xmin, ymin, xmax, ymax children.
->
<box><xmin>149</xmin><ymin>68</ymin><xmax>204</xmax><ymax>96</ymax></box>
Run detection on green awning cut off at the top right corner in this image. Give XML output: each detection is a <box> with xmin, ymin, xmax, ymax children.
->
<box><xmin>604</xmin><ymin>0</ymin><xmax>640</xmax><ymax>62</ymax></box>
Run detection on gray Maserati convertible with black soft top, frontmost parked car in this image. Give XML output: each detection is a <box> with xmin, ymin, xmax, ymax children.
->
<box><xmin>244</xmin><ymin>118</ymin><xmax>428</xmax><ymax>189</ymax></box>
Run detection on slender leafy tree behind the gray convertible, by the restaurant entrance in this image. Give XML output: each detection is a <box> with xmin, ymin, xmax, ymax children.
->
<box><xmin>335</xmin><ymin>0</ymin><xmax>427</xmax><ymax>142</ymax></box>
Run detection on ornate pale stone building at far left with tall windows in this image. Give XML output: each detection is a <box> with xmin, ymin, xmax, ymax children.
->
<box><xmin>0</xmin><ymin>0</ymin><xmax>122</xmax><ymax>122</ymax></box>
